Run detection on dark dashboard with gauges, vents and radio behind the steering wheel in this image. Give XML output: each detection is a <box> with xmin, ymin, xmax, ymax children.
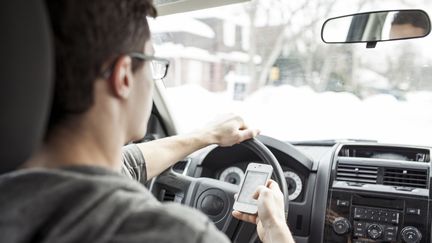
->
<box><xmin>163</xmin><ymin>136</ymin><xmax>432</xmax><ymax>243</ymax></box>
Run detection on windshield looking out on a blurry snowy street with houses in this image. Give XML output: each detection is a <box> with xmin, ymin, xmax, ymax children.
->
<box><xmin>150</xmin><ymin>0</ymin><xmax>432</xmax><ymax>146</ymax></box>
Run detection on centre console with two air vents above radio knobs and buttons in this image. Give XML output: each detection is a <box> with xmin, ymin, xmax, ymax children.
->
<box><xmin>324</xmin><ymin>144</ymin><xmax>432</xmax><ymax>243</ymax></box>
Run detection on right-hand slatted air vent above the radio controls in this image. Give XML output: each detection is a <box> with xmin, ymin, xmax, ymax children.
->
<box><xmin>383</xmin><ymin>168</ymin><xmax>428</xmax><ymax>188</ymax></box>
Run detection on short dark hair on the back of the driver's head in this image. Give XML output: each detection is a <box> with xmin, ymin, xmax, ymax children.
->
<box><xmin>46</xmin><ymin>0</ymin><xmax>157</xmax><ymax>132</ymax></box>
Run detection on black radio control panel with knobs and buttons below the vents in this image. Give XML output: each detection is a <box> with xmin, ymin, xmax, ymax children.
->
<box><xmin>324</xmin><ymin>190</ymin><xmax>431</xmax><ymax>243</ymax></box>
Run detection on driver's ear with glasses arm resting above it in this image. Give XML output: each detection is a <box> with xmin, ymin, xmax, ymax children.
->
<box><xmin>109</xmin><ymin>56</ymin><xmax>133</xmax><ymax>99</ymax></box>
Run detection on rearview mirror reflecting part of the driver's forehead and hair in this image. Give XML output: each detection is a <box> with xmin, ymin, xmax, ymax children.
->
<box><xmin>321</xmin><ymin>10</ymin><xmax>431</xmax><ymax>48</ymax></box>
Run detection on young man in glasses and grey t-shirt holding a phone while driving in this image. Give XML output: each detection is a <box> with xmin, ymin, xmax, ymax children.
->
<box><xmin>0</xmin><ymin>0</ymin><xmax>293</xmax><ymax>243</ymax></box>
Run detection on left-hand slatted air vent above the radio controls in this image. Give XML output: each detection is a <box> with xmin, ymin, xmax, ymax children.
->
<box><xmin>336</xmin><ymin>162</ymin><xmax>378</xmax><ymax>184</ymax></box>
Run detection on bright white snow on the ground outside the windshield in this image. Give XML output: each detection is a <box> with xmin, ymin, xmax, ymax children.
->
<box><xmin>167</xmin><ymin>85</ymin><xmax>432</xmax><ymax>146</ymax></box>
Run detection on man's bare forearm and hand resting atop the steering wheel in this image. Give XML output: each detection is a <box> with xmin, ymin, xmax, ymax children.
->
<box><xmin>138</xmin><ymin>115</ymin><xmax>258</xmax><ymax>180</ymax></box>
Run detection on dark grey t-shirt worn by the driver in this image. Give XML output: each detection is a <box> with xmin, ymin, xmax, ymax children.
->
<box><xmin>0</xmin><ymin>146</ymin><xmax>229</xmax><ymax>243</ymax></box>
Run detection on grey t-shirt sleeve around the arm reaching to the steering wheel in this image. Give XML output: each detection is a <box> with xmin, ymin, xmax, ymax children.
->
<box><xmin>122</xmin><ymin>144</ymin><xmax>147</xmax><ymax>182</ymax></box>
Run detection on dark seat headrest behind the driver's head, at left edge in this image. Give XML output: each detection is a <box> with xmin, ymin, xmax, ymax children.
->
<box><xmin>0</xmin><ymin>0</ymin><xmax>53</xmax><ymax>173</ymax></box>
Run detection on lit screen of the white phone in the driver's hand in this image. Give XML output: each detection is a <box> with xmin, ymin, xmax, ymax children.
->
<box><xmin>237</xmin><ymin>171</ymin><xmax>268</xmax><ymax>205</ymax></box>
